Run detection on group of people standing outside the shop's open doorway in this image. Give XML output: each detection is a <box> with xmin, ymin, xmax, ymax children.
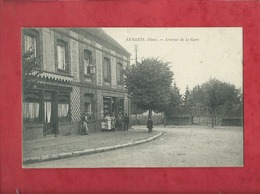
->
<box><xmin>101</xmin><ymin>112</ymin><xmax>129</xmax><ymax>131</ymax></box>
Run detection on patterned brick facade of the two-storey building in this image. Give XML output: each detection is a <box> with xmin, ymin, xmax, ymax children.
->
<box><xmin>22</xmin><ymin>28</ymin><xmax>130</xmax><ymax>140</ymax></box>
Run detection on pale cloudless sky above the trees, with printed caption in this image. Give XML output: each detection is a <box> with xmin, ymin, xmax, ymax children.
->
<box><xmin>103</xmin><ymin>27</ymin><xmax>243</xmax><ymax>94</ymax></box>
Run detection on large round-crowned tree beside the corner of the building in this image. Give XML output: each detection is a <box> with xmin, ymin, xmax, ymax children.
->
<box><xmin>125</xmin><ymin>58</ymin><xmax>173</xmax><ymax>117</ymax></box>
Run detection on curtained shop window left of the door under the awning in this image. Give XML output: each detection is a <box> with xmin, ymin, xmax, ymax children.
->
<box><xmin>23</xmin><ymin>90</ymin><xmax>41</xmax><ymax>123</ymax></box>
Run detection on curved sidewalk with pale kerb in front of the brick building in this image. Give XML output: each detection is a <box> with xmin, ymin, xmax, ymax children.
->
<box><xmin>23</xmin><ymin>128</ymin><xmax>162</xmax><ymax>164</ymax></box>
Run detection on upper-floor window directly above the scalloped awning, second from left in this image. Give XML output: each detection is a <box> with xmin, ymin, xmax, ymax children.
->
<box><xmin>57</xmin><ymin>40</ymin><xmax>68</xmax><ymax>71</ymax></box>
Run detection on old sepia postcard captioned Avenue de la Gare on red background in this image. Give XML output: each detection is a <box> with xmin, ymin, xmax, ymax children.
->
<box><xmin>21</xmin><ymin>27</ymin><xmax>244</xmax><ymax>168</ymax></box>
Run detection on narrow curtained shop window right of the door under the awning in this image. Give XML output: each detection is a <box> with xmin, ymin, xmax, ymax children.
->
<box><xmin>58</xmin><ymin>92</ymin><xmax>70</xmax><ymax>122</ymax></box>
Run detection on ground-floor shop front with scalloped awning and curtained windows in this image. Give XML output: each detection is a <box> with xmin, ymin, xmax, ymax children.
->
<box><xmin>22</xmin><ymin>70</ymin><xmax>72</xmax><ymax>140</ymax></box>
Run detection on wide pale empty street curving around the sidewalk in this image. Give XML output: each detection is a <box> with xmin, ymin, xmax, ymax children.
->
<box><xmin>27</xmin><ymin>126</ymin><xmax>243</xmax><ymax>168</ymax></box>
